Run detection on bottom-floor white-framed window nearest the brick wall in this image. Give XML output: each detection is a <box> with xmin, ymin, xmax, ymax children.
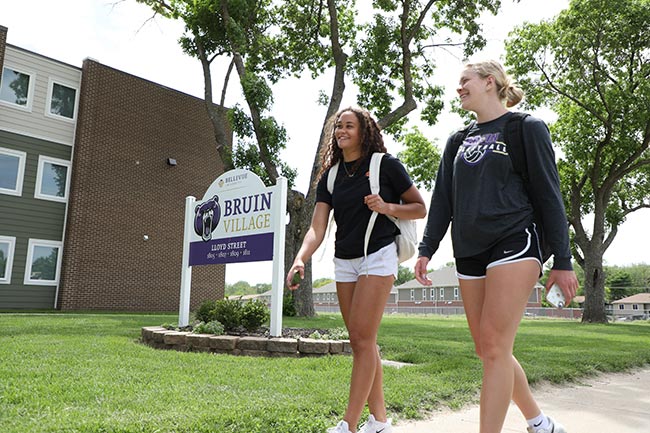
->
<box><xmin>25</xmin><ymin>239</ymin><xmax>62</xmax><ymax>286</ymax></box>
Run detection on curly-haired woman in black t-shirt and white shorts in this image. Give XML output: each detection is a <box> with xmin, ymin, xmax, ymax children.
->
<box><xmin>286</xmin><ymin>108</ymin><xmax>426</xmax><ymax>433</ymax></box>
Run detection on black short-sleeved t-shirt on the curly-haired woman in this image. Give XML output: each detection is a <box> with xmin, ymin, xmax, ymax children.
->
<box><xmin>316</xmin><ymin>154</ymin><xmax>413</xmax><ymax>259</ymax></box>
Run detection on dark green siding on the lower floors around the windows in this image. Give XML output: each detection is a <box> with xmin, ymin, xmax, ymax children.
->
<box><xmin>0</xmin><ymin>126</ymin><xmax>72</xmax><ymax>309</ymax></box>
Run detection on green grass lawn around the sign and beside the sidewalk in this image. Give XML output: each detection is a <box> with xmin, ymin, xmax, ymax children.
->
<box><xmin>0</xmin><ymin>313</ymin><xmax>650</xmax><ymax>433</ymax></box>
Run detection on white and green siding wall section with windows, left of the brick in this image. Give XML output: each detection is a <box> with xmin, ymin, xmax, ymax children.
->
<box><xmin>0</xmin><ymin>26</ymin><xmax>81</xmax><ymax>309</ymax></box>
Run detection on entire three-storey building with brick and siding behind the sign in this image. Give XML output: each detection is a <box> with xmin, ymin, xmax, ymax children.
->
<box><xmin>0</xmin><ymin>26</ymin><xmax>225</xmax><ymax>311</ymax></box>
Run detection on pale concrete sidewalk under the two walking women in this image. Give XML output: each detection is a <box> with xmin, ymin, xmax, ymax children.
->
<box><xmin>393</xmin><ymin>367</ymin><xmax>650</xmax><ymax>433</ymax></box>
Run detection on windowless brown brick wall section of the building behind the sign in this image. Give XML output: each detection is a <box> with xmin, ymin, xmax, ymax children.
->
<box><xmin>58</xmin><ymin>59</ymin><xmax>225</xmax><ymax>311</ymax></box>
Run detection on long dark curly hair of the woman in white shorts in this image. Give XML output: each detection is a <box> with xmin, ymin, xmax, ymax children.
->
<box><xmin>316</xmin><ymin>107</ymin><xmax>386</xmax><ymax>179</ymax></box>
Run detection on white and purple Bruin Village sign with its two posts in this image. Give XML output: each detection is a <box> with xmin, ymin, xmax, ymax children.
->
<box><xmin>179</xmin><ymin>169</ymin><xmax>287</xmax><ymax>336</ymax></box>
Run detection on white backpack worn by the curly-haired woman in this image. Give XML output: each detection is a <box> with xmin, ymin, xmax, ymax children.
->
<box><xmin>327</xmin><ymin>152</ymin><xmax>418</xmax><ymax>263</ymax></box>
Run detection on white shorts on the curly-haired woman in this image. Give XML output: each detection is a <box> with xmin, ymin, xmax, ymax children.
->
<box><xmin>334</xmin><ymin>242</ymin><xmax>398</xmax><ymax>283</ymax></box>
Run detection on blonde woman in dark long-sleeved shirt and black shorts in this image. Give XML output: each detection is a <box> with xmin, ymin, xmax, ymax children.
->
<box><xmin>415</xmin><ymin>61</ymin><xmax>578</xmax><ymax>433</ymax></box>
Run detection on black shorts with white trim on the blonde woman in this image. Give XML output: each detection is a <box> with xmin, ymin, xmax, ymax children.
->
<box><xmin>456</xmin><ymin>223</ymin><xmax>542</xmax><ymax>279</ymax></box>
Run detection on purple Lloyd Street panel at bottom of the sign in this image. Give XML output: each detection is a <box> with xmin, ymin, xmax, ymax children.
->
<box><xmin>189</xmin><ymin>233</ymin><xmax>273</xmax><ymax>266</ymax></box>
